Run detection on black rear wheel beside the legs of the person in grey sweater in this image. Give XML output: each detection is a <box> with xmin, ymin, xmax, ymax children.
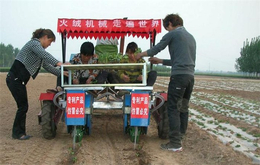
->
<box><xmin>157</xmin><ymin>102</ymin><xmax>169</xmax><ymax>139</ymax></box>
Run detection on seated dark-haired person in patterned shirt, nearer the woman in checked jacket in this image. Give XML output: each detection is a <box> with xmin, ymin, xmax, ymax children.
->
<box><xmin>71</xmin><ymin>42</ymin><xmax>107</xmax><ymax>84</ymax></box>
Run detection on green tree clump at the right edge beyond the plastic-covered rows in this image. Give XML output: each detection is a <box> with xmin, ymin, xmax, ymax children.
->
<box><xmin>235</xmin><ymin>36</ymin><xmax>260</xmax><ymax>75</ymax></box>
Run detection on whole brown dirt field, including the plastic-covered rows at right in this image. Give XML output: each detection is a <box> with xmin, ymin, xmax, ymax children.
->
<box><xmin>0</xmin><ymin>73</ymin><xmax>260</xmax><ymax>165</ymax></box>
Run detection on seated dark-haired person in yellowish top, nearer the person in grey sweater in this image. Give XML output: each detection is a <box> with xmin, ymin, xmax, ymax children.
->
<box><xmin>118</xmin><ymin>42</ymin><xmax>157</xmax><ymax>86</ymax></box>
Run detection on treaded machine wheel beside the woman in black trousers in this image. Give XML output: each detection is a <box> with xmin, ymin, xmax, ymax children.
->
<box><xmin>41</xmin><ymin>101</ymin><xmax>57</xmax><ymax>139</ymax></box>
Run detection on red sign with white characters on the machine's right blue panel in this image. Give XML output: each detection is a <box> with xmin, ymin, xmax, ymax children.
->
<box><xmin>131</xmin><ymin>93</ymin><xmax>149</xmax><ymax>119</ymax></box>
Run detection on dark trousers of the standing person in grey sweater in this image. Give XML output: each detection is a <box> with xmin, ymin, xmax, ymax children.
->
<box><xmin>167</xmin><ymin>74</ymin><xmax>194</xmax><ymax>148</ymax></box>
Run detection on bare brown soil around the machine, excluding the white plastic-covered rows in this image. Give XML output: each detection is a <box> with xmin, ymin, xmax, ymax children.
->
<box><xmin>0</xmin><ymin>73</ymin><xmax>260</xmax><ymax>165</ymax></box>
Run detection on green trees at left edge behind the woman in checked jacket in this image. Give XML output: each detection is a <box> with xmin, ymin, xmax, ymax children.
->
<box><xmin>0</xmin><ymin>43</ymin><xmax>20</xmax><ymax>67</ymax></box>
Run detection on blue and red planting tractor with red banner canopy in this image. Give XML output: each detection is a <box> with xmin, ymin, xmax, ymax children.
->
<box><xmin>38</xmin><ymin>18</ymin><xmax>168</xmax><ymax>148</ymax></box>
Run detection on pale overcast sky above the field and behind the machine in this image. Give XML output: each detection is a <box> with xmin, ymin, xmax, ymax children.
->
<box><xmin>0</xmin><ymin>0</ymin><xmax>260</xmax><ymax>71</ymax></box>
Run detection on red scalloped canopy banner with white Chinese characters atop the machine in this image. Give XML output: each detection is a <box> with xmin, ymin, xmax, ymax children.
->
<box><xmin>57</xmin><ymin>18</ymin><xmax>161</xmax><ymax>38</ymax></box>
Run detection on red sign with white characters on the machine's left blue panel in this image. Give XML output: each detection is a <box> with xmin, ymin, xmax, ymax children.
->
<box><xmin>66</xmin><ymin>93</ymin><xmax>85</xmax><ymax>118</ymax></box>
